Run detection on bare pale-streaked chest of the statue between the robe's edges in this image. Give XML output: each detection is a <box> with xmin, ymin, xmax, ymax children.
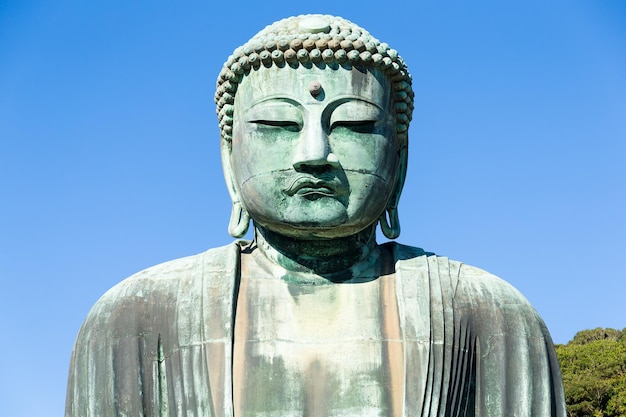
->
<box><xmin>233</xmin><ymin>264</ymin><xmax>401</xmax><ymax>417</ymax></box>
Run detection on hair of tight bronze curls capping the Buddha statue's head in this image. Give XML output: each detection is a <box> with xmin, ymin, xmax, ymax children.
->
<box><xmin>215</xmin><ymin>14</ymin><xmax>413</xmax><ymax>144</ymax></box>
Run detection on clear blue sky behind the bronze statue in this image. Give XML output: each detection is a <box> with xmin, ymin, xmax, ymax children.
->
<box><xmin>0</xmin><ymin>0</ymin><xmax>626</xmax><ymax>417</ymax></box>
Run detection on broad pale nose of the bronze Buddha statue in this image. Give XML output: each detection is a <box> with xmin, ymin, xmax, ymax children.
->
<box><xmin>292</xmin><ymin>126</ymin><xmax>339</xmax><ymax>171</ymax></box>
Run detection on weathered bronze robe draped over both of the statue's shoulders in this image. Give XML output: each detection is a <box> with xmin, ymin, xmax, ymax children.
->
<box><xmin>65</xmin><ymin>242</ymin><xmax>565</xmax><ymax>417</ymax></box>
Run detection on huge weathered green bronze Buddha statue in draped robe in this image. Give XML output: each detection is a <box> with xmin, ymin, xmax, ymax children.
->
<box><xmin>66</xmin><ymin>15</ymin><xmax>565</xmax><ymax>417</ymax></box>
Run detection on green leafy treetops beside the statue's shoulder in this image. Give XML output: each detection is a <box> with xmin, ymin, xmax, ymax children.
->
<box><xmin>556</xmin><ymin>328</ymin><xmax>626</xmax><ymax>417</ymax></box>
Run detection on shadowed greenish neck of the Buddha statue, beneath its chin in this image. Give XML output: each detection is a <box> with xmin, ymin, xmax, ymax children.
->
<box><xmin>255</xmin><ymin>223</ymin><xmax>376</xmax><ymax>275</ymax></box>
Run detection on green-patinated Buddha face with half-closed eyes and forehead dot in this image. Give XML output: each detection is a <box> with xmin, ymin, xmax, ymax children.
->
<box><xmin>226</xmin><ymin>66</ymin><xmax>399</xmax><ymax>239</ymax></box>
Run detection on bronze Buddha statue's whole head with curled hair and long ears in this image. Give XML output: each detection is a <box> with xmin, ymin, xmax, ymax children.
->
<box><xmin>215</xmin><ymin>15</ymin><xmax>413</xmax><ymax>239</ymax></box>
